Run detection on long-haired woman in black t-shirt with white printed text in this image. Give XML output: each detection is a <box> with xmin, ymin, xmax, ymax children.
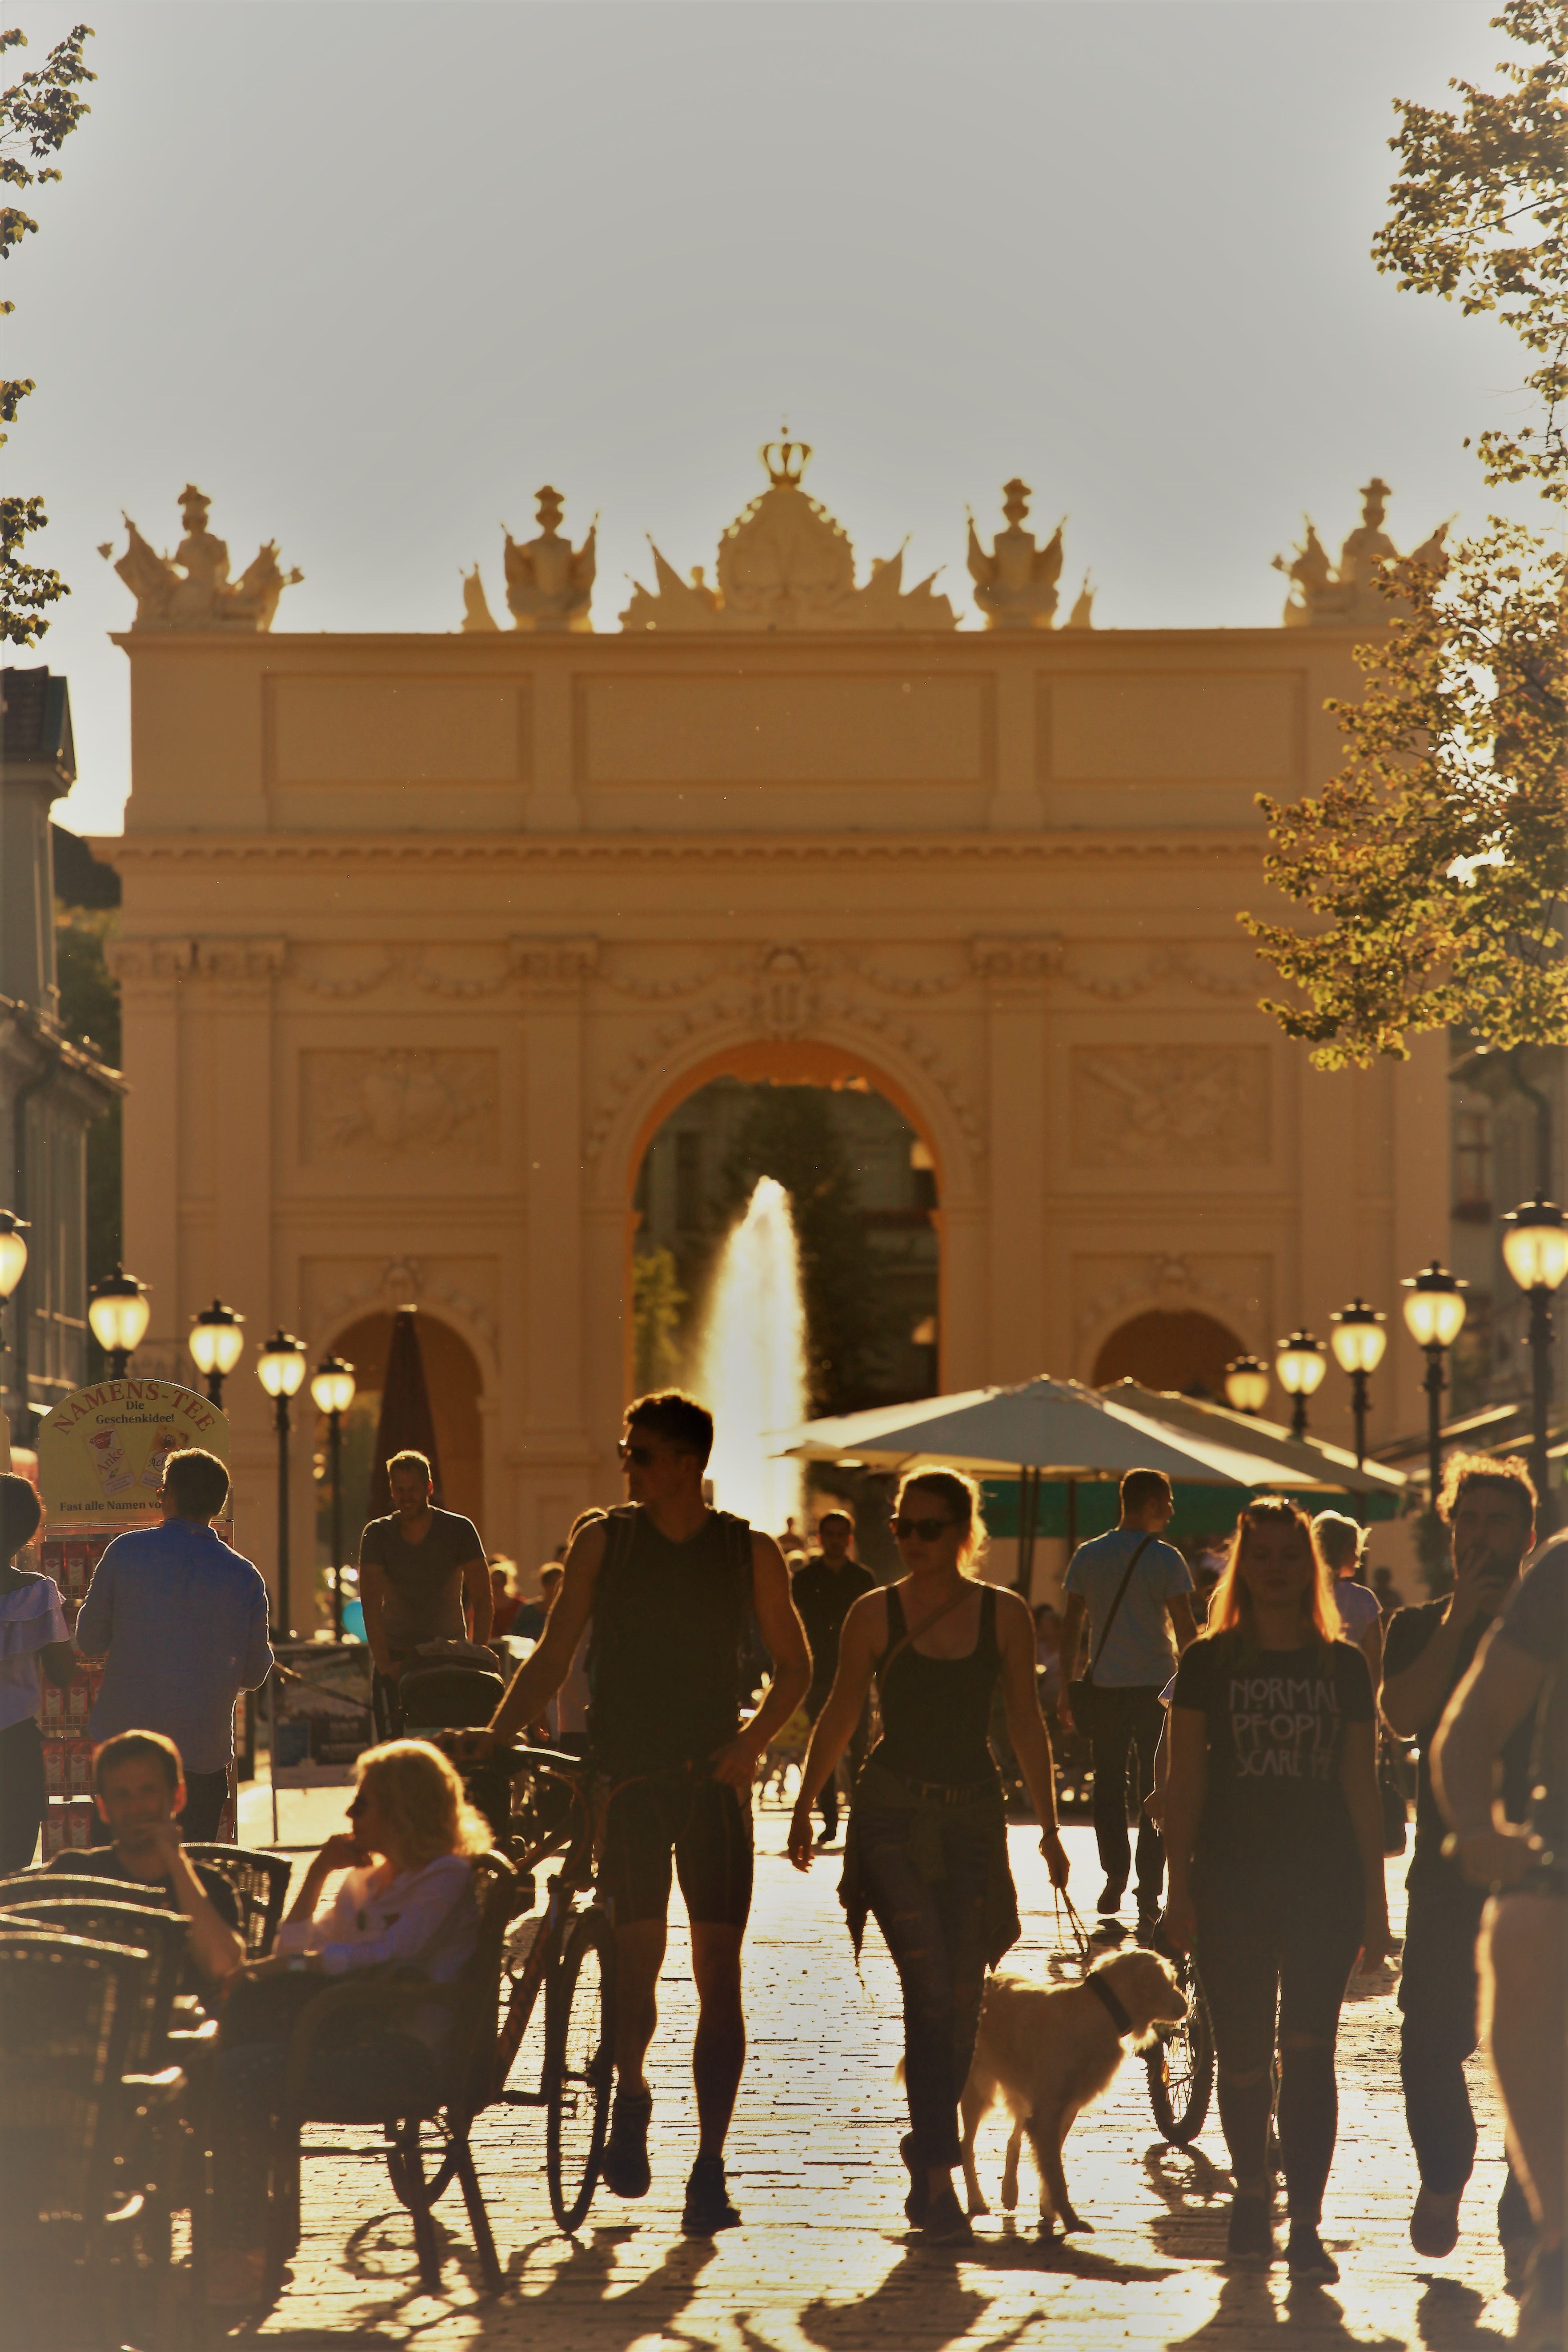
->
<box><xmin>1163</xmin><ymin>1496</ymin><xmax>1389</xmax><ymax>2279</ymax></box>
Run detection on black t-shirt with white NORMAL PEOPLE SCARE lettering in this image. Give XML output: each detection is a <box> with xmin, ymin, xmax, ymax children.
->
<box><xmin>1171</xmin><ymin>1630</ymin><xmax>1373</xmax><ymax>1877</ymax></box>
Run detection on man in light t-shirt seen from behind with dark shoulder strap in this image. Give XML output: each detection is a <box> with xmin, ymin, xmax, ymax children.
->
<box><xmin>1058</xmin><ymin>1470</ymin><xmax>1197</xmax><ymax>1935</ymax></box>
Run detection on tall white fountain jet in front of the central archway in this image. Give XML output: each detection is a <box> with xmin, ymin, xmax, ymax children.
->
<box><xmin>696</xmin><ymin>1176</ymin><xmax>806</xmax><ymax>1536</ymax></box>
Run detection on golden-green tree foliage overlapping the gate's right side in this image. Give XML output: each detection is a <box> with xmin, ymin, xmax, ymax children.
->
<box><xmin>1241</xmin><ymin>520</ymin><xmax>1568</xmax><ymax>1070</ymax></box>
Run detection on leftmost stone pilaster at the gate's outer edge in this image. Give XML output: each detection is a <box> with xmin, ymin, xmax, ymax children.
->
<box><xmin>108</xmin><ymin>938</ymin><xmax>195</xmax><ymax>1378</ymax></box>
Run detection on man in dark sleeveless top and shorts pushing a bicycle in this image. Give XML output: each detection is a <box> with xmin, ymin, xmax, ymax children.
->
<box><xmin>461</xmin><ymin>1390</ymin><xmax>811</xmax><ymax>2237</ymax></box>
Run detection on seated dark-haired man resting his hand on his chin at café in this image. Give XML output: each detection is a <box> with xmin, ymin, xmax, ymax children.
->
<box><xmin>44</xmin><ymin>1731</ymin><xmax>245</xmax><ymax>1999</ymax></box>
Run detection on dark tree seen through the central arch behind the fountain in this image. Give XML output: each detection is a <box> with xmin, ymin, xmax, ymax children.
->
<box><xmin>724</xmin><ymin>1086</ymin><xmax>896</xmax><ymax>1414</ymax></box>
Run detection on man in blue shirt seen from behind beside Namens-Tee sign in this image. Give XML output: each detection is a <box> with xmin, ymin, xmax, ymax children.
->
<box><xmin>75</xmin><ymin>1446</ymin><xmax>273</xmax><ymax>1844</ymax></box>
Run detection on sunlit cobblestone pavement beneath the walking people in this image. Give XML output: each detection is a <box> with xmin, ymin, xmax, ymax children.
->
<box><xmin>252</xmin><ymin>1799</ymin><xmax>1514</xmax><ymax>2352</ymax></box>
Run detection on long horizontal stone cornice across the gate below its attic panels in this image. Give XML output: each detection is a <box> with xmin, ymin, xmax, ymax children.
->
<box><xmin>92</xmin><ymin>825</ymin><xmax>1267</xmax><ymax>873</ymax></box>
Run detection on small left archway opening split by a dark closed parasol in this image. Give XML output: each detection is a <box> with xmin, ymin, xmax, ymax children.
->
<box><xmin>315</xmin><ymin>1308</ymin><xmax>484</xmax><ymax>1571</ymax></box>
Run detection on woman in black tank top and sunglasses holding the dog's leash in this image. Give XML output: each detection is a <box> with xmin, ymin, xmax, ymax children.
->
<box><xmin>790</xmin><ymin>1470</ymin><xmax>1067</xmax><ymax>2241</ymax></box>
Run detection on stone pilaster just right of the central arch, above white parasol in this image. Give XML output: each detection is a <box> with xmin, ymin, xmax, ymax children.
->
<box><xmin>969</xmin><ymin>936</ymin><xmax>1063</xmax><ymax>1381</ymax></box>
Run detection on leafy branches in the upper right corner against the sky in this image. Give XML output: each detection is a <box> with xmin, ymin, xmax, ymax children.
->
<box><xmin>1373</xmin><ymin>0</ymin><xmax>1568</xmax><ymax>499</ymax></box>
